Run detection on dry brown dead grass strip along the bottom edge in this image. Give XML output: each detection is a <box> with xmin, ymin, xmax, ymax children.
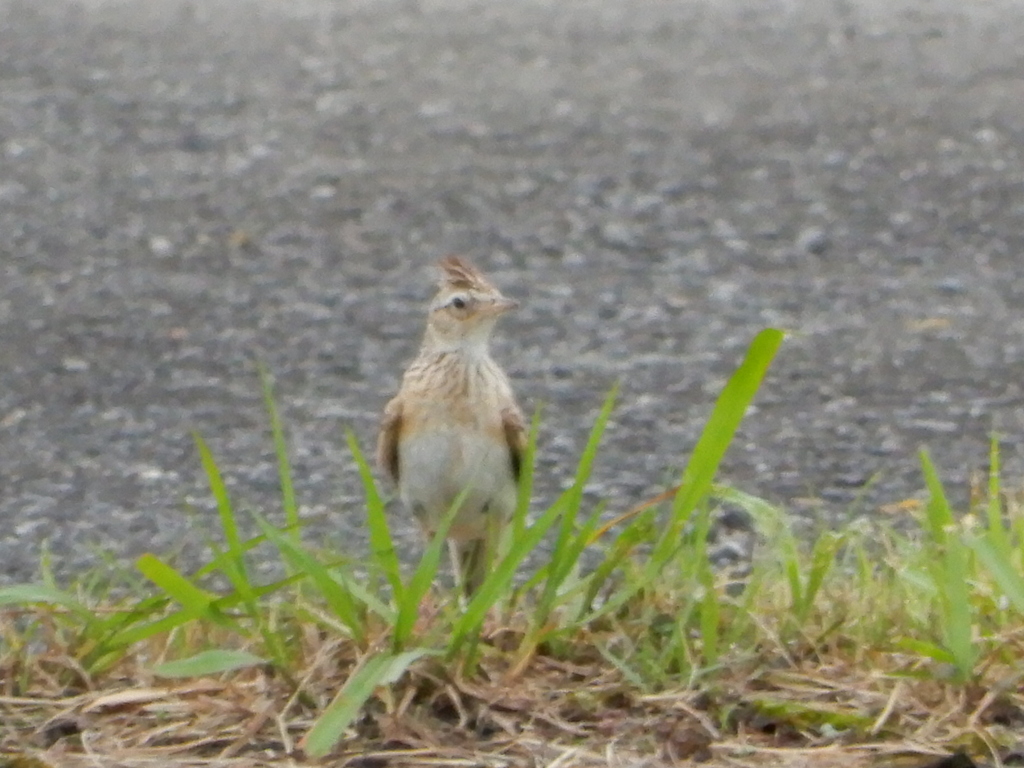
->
<box><xmin>0</xmin><ymin>627</ymin><xmax>1011</xmax><ymax>768</ymax></box>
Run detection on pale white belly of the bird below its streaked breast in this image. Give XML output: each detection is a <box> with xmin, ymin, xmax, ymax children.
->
<box><xmin>399</xmin><ymin>429</ymin><xmax>516</xmax><ymax>541</ymax></box>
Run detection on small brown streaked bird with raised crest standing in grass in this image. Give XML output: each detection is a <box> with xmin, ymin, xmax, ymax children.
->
<box><xmin>377</xmin><ymin>256</ymin><xmax>526</xmax><ymax>595</ymax></box>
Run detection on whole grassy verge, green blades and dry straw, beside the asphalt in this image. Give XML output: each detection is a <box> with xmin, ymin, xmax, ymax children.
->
<box><xmin>0</xmin><ymin>331</ymin><xmax>1024</xmax><ymax>766</ymax></box>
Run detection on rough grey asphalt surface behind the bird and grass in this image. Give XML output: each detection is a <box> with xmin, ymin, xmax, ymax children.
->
<box><xmin>0</xmin><ymin>0</ymin><xmax>1024</xmax><ymax>581</ymax></box>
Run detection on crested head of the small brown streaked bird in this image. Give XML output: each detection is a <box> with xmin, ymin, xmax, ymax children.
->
<box><xmin>426</xmin><ymin>256</ymin><xmax>519</xmax><ymax>352</ymax></box>
